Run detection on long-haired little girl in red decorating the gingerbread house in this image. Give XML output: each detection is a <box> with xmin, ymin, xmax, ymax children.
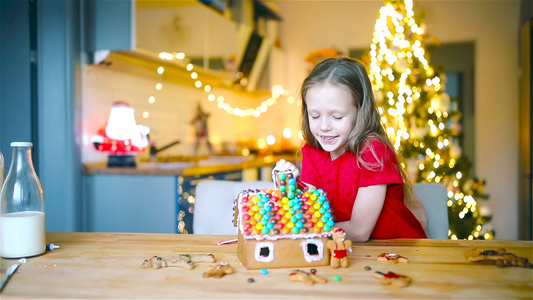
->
<box><xmin>274</xmin><ymin>58</ymin><xmax>427</xmax><ymax>242</ymax></box>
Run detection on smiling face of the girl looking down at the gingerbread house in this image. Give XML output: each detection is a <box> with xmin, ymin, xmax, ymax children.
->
<box><xmin>305</xmin><ymin>83</ymin><xmax>357</xmax><ymax>160</ymax></box>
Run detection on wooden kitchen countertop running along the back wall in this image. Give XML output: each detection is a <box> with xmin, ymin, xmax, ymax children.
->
<box><xmin>83</xmin><ymin>155</ymin><xmax>296</xmax><ymax>176</ymax></box>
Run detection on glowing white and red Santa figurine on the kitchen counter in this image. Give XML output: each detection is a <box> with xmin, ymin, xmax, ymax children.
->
<box><xmin>92</xmin><ymin>101</ymin><xmax>150</xmax><ymax>167</ymax></box>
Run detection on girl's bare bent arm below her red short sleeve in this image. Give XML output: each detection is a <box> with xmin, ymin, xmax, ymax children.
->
<box><xmin>335</xmin><ymin>184</ymin><xmax>387</xmax><ymax>242</ymax></box>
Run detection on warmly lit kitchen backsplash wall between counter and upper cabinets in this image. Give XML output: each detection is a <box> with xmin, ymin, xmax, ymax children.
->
<box><xmin>82</xmin><ymin>65</ymin><xmax>297</xmax><ymax>163</ymax></box>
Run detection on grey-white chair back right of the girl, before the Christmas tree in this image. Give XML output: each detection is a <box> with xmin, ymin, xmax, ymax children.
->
<box><xmin>413</xmin><ymin>183</ymin><xmax>449</xmax><ymax>239</ymax></box>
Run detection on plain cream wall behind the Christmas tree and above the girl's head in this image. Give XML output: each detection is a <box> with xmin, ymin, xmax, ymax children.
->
<box><xmin>271</xmin><ymin>0</ymin><xmax>520</xmax><ymax>239</ymax></box>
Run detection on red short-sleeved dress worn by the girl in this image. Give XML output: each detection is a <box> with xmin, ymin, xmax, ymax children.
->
<box><xmin>301</xmin><ymin>141</ymin><xmax>427</xmax><ymax>239</ymax></box>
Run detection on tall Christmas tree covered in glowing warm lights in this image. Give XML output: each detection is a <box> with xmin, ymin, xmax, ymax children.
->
<box><xmin>368</xmin><ymin>0</ymin><xmax>494</xmax><ymax>239</ymax></box>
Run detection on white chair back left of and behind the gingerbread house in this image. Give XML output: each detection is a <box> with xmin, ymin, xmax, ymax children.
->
<box><xmin>192</xmin><ymin>180</ymin><xmax>274</xmax><ymax>234</ymax></box>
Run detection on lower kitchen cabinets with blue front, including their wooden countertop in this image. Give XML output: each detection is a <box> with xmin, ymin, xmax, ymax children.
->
<box><xmin>82</xmin><ymin>155</ymin><xmax>295</xmax><ymax>233</ymax></box>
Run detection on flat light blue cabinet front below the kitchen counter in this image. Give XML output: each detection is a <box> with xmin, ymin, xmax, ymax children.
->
<box><xmin>83</xmin><ymin>174</ymin><xmax>177</xmax><ymax>233</ymax></box>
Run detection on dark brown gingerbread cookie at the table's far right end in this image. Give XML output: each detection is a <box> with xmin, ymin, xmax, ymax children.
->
<box><xmin>465</xmin><ymin>248</ymin><xmax>533</xmax><ymax>269</ymax></box>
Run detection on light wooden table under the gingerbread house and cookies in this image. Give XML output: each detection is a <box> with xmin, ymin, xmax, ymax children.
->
<box><xmin>0</xmin><ymin>232</ymin><xmax>533</xmax><ymax>299</ymax></box>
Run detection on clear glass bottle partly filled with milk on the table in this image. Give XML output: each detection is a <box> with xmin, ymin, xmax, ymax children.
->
<box><xmin>0</xmin><ymin>142</ymin><xmax>46</xmax><ymax>258</ymax></box>
